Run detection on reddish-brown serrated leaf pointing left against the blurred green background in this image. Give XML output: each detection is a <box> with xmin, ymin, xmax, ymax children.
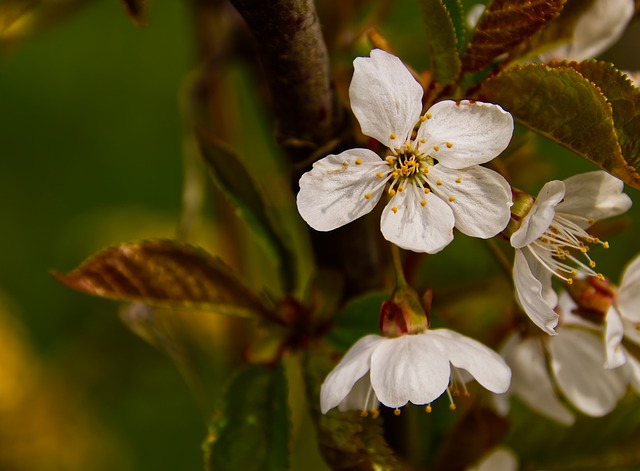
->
<box><xmin>54</xmin><ymin>240</ymin><xmax>266</xmax><ymax>317</ymax></box>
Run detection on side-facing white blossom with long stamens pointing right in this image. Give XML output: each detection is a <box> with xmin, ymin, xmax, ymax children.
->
<box><xmin>511</xmin><ymin>171</ymin><xmax>631</xmax><ymax>334</ymax></box>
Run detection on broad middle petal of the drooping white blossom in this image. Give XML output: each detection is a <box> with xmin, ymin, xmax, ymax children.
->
<box><xmin>371</xmin><ymin>333</ymin><xmax>451</xmax><ymax>408</ymax></box>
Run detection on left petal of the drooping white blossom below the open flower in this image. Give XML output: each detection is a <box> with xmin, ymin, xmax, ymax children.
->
<box><xmin>320</xmin><ymin>335</ymin><xmax>386</xmax><ymax>414</ymax></box>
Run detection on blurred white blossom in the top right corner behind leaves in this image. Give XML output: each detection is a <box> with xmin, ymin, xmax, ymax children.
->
<box><xmin>540</xmin><ymin>0</ymin><xmax>635</xmax><ymax>62</ymax></box>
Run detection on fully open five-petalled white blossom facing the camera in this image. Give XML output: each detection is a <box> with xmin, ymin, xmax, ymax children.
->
<box><xmin>297</xmin><ymin>49</ymin><xmax>513</xmax><ymax>253</ymax></box>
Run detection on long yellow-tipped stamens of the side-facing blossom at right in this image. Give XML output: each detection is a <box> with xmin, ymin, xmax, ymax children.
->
<box><xmin>529</xmin><ymin>213</ymin><xmax>609</xmax><ymax>284</ymax></box>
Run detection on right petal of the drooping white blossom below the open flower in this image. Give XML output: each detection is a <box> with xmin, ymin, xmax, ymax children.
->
<box><xmin>426</xmin><ymin>329</ymin><xmax>511</xmax><ymax>394</ymax></box>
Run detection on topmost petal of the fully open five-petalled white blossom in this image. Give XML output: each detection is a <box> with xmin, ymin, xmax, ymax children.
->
<box><xmin>349</xmin><ymin>49</ymin><xmax>423</xmax><ymax>148</ymax></box>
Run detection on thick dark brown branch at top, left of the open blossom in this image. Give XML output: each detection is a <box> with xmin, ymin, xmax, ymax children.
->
<box><xmin>231</xmin><ymin>0</ymin><xmax>341</xmax><ymax>162</ymax></box>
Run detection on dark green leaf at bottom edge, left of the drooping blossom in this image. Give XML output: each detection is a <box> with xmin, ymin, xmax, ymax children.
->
<box><xmin>203</xmin><ymin>363</ymin><xmax>291</xmax><ymax>471</ymax></box>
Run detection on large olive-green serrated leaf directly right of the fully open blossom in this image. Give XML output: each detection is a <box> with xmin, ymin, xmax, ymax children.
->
<box><xmin>482</xmin><ymin>64</ymin><xmax>640</xmax><ymax>187</ymax></box>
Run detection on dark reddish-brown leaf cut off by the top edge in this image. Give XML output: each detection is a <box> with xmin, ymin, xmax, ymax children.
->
<box><xmin>462</xmin><ymin>0</ymin><xmax>565</xmax><ymax>71</ymax></box>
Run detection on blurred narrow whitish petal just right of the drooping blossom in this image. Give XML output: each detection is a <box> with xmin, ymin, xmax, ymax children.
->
<box><xmin>502</xmin><ymin>337</ymin><xmax>575</xmax><ymax>425</ymax></box>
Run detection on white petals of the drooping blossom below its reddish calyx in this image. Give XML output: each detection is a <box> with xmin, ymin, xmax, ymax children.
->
<box><xmin>320</xmin><ymin>329</ymin><xmax>511</xmax><ymax>414</ymax></box>
